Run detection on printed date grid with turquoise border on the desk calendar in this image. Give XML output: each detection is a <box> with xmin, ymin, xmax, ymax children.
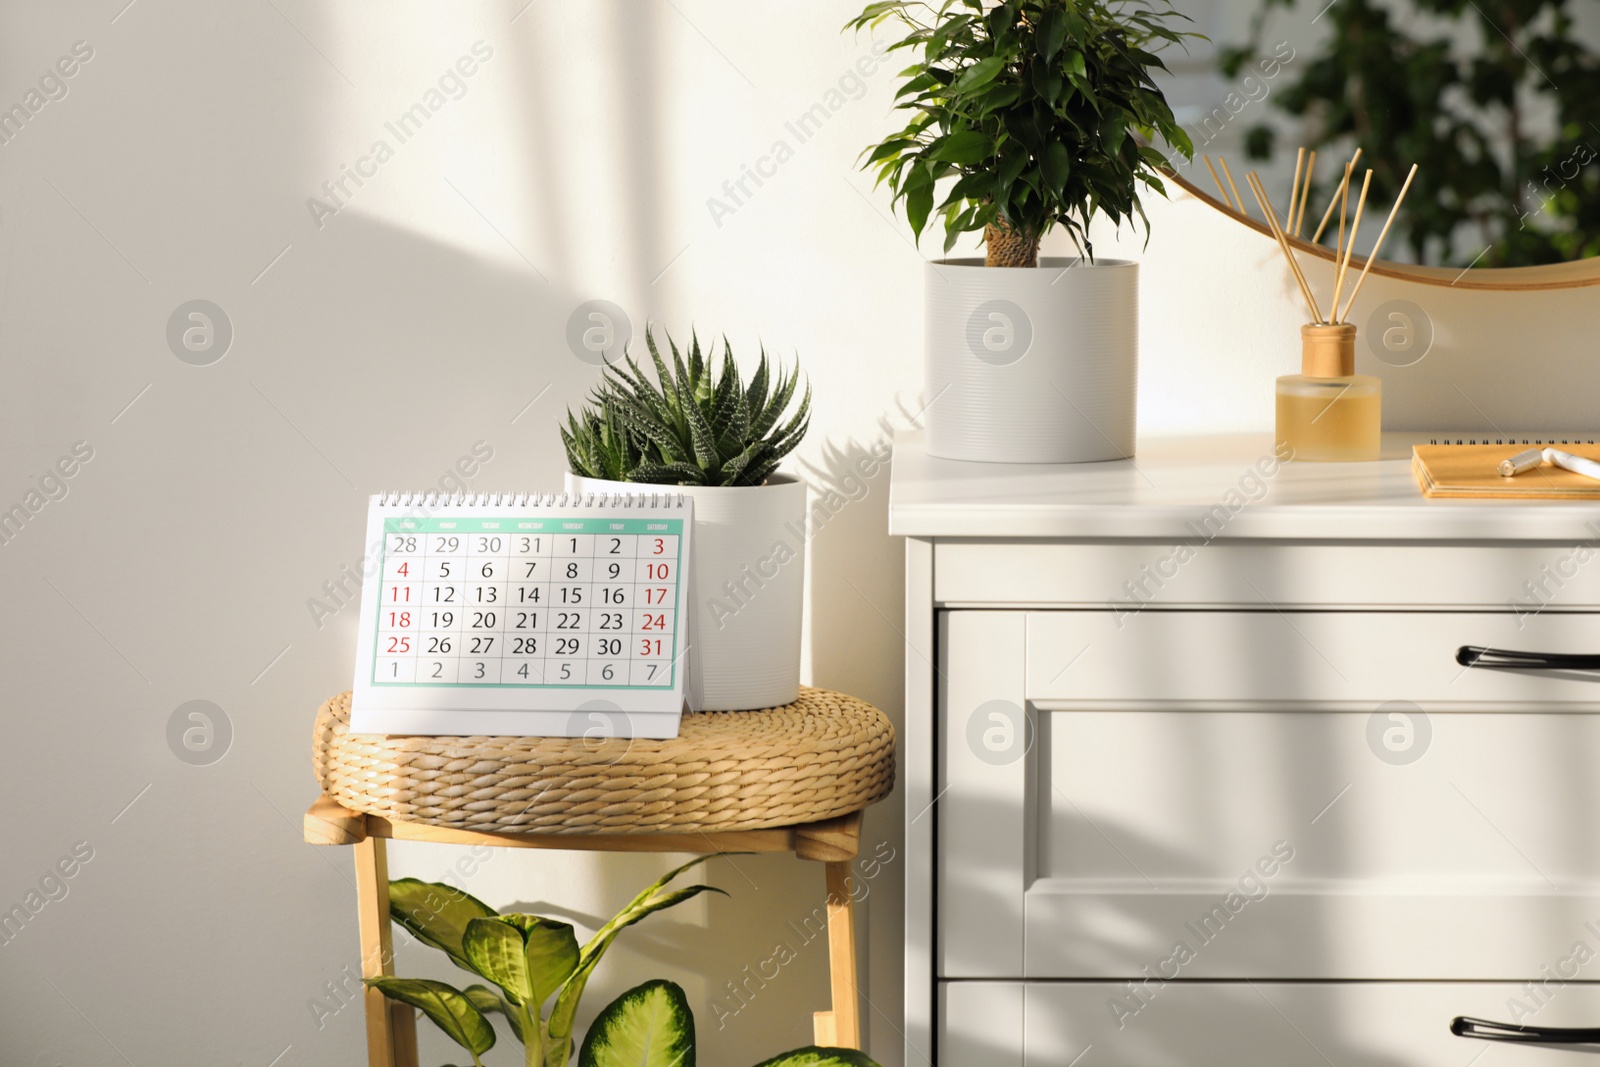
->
<box><xmin>370</xmin><ymin>517</ymin><xmax>685</xmax><ymax>691</ymax></box>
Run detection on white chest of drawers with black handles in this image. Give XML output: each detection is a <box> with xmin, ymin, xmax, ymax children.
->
<box><xmin>890</xmin><ymin>435</ymin><xmax>1600</xmax><ymax>1067</ymax></box>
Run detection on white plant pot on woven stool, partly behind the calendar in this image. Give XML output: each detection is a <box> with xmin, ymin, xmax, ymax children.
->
<box><xmin>566</xmin><ymin>474</ymin><xmax>806</xmax><ymax>712</ymax></box>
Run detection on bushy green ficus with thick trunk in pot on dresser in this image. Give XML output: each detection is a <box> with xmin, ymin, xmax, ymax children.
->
<box><xmin>846</xmin><ymin>0</ymin><xmax>1198</xmax><ymax>267</ymax></box>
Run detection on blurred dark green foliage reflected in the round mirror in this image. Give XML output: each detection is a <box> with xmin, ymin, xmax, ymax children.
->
<box><xmin>1222</xmin><ymin>0</ymin><xmax>1600</xmax><ymax>267</ymax></box>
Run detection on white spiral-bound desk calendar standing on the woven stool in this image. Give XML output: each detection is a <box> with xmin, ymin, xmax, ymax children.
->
<box><xmin>350</xmin><ymin>493</ymin><xmax>694</xmax><ymax>737</ymax></box>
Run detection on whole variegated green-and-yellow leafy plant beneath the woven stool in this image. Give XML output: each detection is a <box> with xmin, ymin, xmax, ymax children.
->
<box><xmin>365</xmin><ymin>856</ymin><xmax>878</xmax><ymax>1067</ymax></box>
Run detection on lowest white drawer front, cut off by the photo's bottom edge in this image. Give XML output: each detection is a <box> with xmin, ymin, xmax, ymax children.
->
<box><xmin>938</xmin><ymin>985</ymin><xmax>1600</xmax><ymax>1067</ymax></box>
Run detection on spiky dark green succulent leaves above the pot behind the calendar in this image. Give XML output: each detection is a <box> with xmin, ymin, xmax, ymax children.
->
<box><xmin>562</xmin><ymin>328</ymin><xmax>811</xmax><ymax>486</ymax></box>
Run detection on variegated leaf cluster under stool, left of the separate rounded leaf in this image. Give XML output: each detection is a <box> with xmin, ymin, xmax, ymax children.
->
<box><xmin>366</xmin><ymin>856</ymin><xmax>722</xmax><ymax>1067</ymax></box>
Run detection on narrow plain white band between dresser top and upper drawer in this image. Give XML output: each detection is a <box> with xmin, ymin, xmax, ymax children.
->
<box><xmin>934</xmin><ymin>543</ymin><xmax>1600</xmax><ymax>613</ymax></box>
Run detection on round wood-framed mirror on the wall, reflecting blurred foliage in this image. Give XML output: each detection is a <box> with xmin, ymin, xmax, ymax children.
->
<box><xmin>1163</xmin><ymin>0</ymin><xmax>1600</xmax><ymax>290</ymax></box>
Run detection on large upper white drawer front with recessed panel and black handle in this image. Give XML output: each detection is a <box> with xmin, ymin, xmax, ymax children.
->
<box><xmin>934</xmin><ymin>611</ymin><xmax>1600</xmax><ymax>985</ymax></box>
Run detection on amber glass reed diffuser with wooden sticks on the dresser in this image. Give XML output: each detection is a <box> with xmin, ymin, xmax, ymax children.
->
<box><xmin>1206</xmin><ymin>149</ymin><xmax>1418</xmax><ymax>462</ymax></box>
